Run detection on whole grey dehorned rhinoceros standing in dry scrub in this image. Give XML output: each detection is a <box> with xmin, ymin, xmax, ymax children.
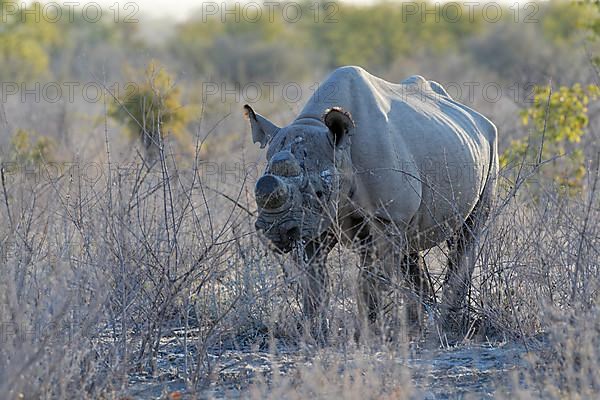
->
<box><xmin>244</xmin><ymin>67</ymin><xmax>498</xmax><ymax>338</ymax></box>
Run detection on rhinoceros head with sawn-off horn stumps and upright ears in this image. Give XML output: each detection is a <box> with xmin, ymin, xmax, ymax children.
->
<box><xmin>244</xmin><ymin>105</ymin><xmax>354</xmax><ymax>252</ymax></box>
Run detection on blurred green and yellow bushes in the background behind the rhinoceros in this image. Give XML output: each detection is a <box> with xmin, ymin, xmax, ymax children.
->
<box><xmin>0</xmin><ymin>0</ymin><xmax>600</xmax><ymax>190</ymax></box>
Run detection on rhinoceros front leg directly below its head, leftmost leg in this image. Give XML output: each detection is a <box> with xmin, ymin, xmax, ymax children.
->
<box><xmin>302</xmin><ymin>237</ymin><xmax>335</xmax><ymax>338</ymax></box>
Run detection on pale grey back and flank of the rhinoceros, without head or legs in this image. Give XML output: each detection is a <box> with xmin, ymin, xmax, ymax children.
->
<box><xmin>297</xmin><ymin>67</ymin><xmax>497</xmax><ymax>248</ymax></box>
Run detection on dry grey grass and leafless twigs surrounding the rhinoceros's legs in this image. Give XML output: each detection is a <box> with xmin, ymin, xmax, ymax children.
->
<box><xmin>0</xmin><ymin>123</ymin><xmax>600</xmax><ymax>399</ymax></box>
